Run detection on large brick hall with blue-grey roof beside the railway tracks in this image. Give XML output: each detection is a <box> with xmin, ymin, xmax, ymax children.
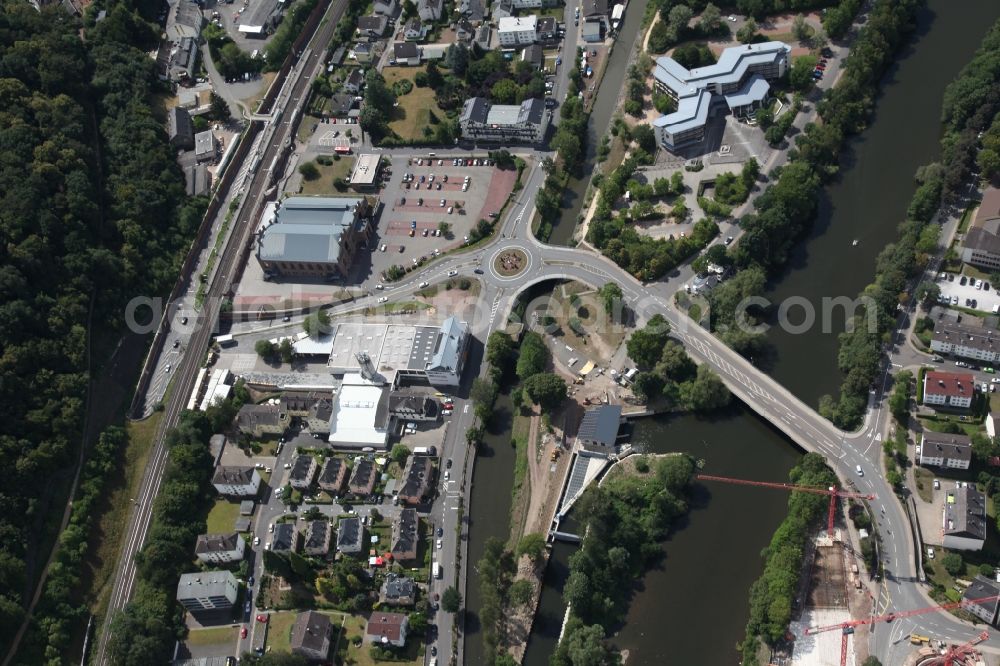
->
<box><xmin>257</xmin><ymin>197</ymin><xmax>372</xmax><ymax>278</ymax></box>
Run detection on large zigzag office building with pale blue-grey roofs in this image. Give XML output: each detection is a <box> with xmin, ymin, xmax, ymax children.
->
<box><xmin>652</xmin><ymin>40</ymin><xmax>792</xmax><ymax>151</ymax></box>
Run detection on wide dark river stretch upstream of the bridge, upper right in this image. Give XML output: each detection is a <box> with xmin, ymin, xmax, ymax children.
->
<box><xmin>765</xmin><ymin>0</ymin><xmax>1000</xmax><ymax>406</ymax></box>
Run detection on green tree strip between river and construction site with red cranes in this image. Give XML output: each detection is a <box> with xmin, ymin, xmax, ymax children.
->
<box><xmin>742</xmin><ymin>453</ymin><xmax>837</xmax><ymax>666</ymax></box>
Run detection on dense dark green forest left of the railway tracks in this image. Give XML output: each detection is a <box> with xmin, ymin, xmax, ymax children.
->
<box><xmin>0</xmin><ymin>0</ymin><xmax>204</xmax><ymax>663</ymax></box>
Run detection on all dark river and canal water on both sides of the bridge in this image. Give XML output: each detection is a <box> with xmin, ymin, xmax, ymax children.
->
<box><xmin>466</xmin><ymin>0</ymin><xmax>1000</xmax><ymax>666</ymax></box>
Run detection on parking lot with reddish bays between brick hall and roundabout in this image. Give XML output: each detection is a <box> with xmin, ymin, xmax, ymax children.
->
<box><xmin>371</xmin><ymin>158</ymin><xmax>517</xmax><ymax>279</ymax></box>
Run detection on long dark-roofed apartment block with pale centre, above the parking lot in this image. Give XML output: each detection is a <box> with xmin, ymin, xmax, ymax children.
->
<box><xmin>459</xmin><ymin>97</ymin><xmax>552</xmax><ymax>144</ymax></box>
